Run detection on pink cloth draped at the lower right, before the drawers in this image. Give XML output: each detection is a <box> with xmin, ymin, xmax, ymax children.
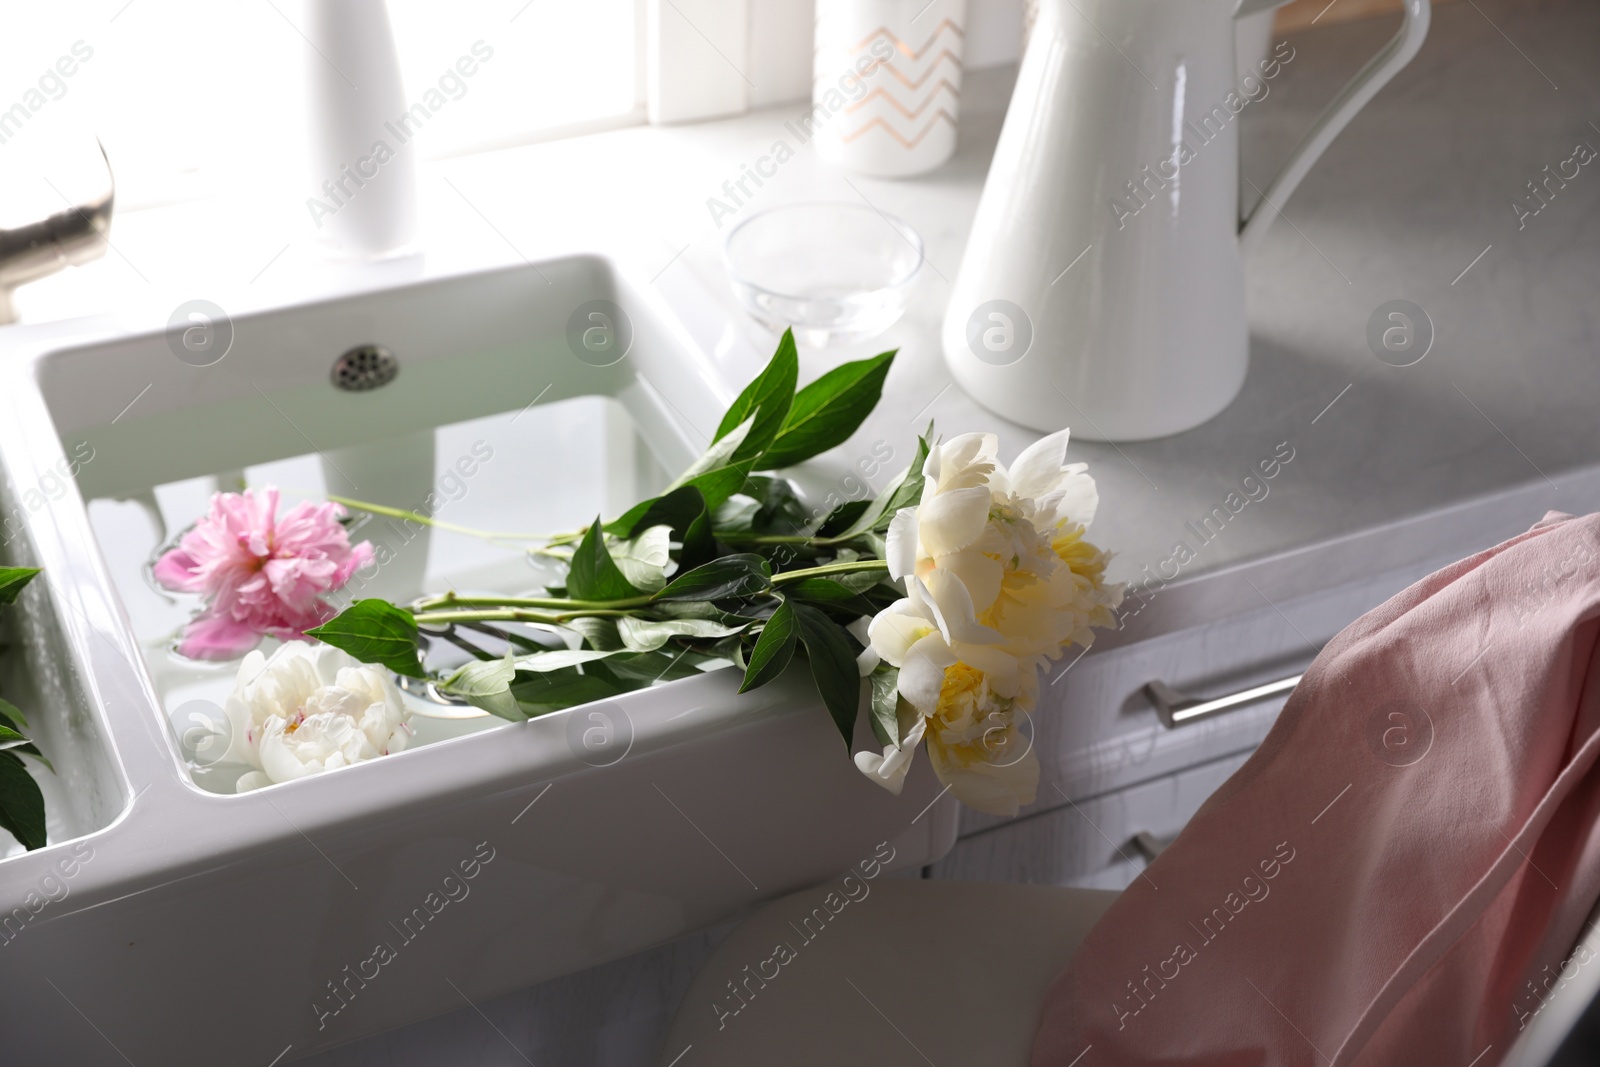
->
<box><xmin>1034</xmin><ymin>512</ymin><xmax>1600</xmax><ymax>1067</ymax></box>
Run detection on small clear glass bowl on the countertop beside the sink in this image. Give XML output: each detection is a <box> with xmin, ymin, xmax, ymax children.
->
<box><xmin>722</xmin><ymin>203</ymin><xmax>923</xmax><ymax>347</ymax></box>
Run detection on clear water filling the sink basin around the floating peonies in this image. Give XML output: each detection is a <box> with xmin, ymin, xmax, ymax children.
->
<box><xmin>78</xmin><ymin>397</ymin><xmax>670</xmax><ymax>793</ymax></box>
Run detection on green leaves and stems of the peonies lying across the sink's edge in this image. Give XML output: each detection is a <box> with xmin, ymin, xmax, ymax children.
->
<box><xmin>308</xmin><ymin>333</ymin><xmax>928</xmax><ymax>755</ymax></box>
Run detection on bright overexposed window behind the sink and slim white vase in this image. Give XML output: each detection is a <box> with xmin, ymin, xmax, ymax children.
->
<box><xmin>0</xmin><ymin>0</ymin><xmax>643</xmax><ymax>208</ymax></box>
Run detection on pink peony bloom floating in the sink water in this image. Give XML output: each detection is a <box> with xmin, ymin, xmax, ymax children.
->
<box><xmin>154</xmin><ymin>485</ymin><xmax>373</xmax><ymax>659</ymax></box>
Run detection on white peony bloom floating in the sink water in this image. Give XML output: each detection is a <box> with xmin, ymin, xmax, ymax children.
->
<box><xmin>222</xmin><ymin>641</ymin><xmax>411</xmax><ymax>792</ymax></box>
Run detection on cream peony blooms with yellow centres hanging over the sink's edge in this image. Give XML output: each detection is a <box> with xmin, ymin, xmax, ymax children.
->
<box><xmin>856</xmin><ymin>430</ymin><xmax>1122</xmax><ymax>816</ymax></box>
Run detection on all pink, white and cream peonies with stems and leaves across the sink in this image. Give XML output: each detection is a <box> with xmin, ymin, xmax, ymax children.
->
<box><xmin>155</xmin><ymin>333</ymin><xmax>1122</xmax><ymax>814</ymax></box>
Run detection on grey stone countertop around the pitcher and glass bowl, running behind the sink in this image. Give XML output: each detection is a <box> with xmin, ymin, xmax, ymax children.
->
<box><xmin>19</xmin><ymin>0</ymin><xmax>1600</xmax><ymax>643</ymax></box>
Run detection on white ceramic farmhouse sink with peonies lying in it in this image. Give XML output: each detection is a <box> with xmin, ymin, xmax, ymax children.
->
<box><xmin>0</xmin><ymin>254</ymin><xmax>955</xmax><ymax>1067</ymax></box>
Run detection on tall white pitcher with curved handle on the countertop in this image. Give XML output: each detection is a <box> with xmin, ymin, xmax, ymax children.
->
<box><xmin>942</xmin><ymin>0</ymin><xmax>1429</xmax><ymax>442</ymax></box>
